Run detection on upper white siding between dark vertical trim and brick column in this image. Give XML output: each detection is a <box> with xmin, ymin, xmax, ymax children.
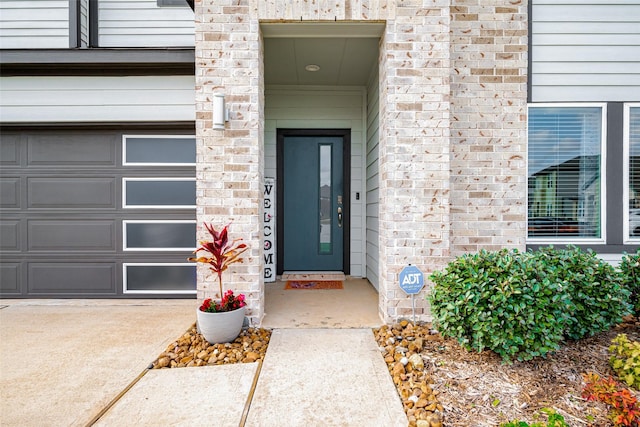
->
<box><xmin>98</xmin><ymin>0</ymin><xmax>195</xmax><ymax>47</ymax></box>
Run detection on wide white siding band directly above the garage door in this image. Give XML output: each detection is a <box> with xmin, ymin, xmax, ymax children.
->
<box><xmin>0</xmin><ymin>76</ymin><xmax>195</xmax><ymax>123</ymax></box>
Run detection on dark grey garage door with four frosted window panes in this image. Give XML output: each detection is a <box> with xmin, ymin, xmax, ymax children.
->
<box><xmin>0</xmin><ymin>129</ymin><xmax>196</xmax><ymax>298</ymax></box>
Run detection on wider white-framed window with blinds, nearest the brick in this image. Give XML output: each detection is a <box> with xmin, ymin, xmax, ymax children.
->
<box><xmin>527</xmin><ymin>105</ymin><xmax>604</xmax><ymax>241</ymax></box>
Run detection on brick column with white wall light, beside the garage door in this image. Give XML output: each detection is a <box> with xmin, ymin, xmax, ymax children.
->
<box><xmin>195</xmin><ymin>0</ymin><xmax>264</xmax><ymax>324</ymax></box>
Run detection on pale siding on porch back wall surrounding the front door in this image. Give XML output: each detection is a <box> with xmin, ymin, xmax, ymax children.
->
<box><xmin>264</xmin><ymin>86</ymin><xmax>365</xmax><ymax>277</ymax></box>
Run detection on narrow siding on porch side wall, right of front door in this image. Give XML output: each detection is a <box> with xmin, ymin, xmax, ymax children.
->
<box><xmin>366</xmin><ymin>72</ymin><xmax>380</xmax><ymax>289</ymax></box>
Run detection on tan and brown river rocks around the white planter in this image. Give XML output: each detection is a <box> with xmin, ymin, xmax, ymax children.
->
<box><xmin>153</xmin><ymin>324</ymin><xmax>271</xmax><ymax>369</ymax></box>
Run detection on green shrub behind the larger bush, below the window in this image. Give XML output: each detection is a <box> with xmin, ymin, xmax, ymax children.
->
<box><xmin>535</xmin><ymin>246</ymin><xmax>631</xmax><ymax>339</ymax></box>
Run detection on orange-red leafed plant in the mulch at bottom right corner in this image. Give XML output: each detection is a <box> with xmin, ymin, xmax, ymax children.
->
<box><xmin>582</xmin><ymin>373</ymin><xmax>640</xmax><ymax>427</ymax></box>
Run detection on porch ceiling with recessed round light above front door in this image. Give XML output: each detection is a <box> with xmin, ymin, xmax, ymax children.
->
<box><xmin>264</xmin><ymin>36</ymin><xmax>379</xmax><ymax>86</ymax></box>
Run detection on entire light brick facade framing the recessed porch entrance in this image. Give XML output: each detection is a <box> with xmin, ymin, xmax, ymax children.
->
<box><xmin>196</xmin><ymin>0</ymin><xmax>527</xmax><ymax>324</ymax></box>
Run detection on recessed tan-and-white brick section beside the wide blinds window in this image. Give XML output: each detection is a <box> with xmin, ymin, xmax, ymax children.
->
<box><xmin>451</xmin><ymin>0</ymin><xmax>528</xmax><ymax>255</ymax></box>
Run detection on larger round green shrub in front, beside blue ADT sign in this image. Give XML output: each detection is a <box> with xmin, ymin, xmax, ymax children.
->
<box><xmin>429</xmin><ymin>249</ymin><xmax>571</xmax><ymax>361</ymax></box>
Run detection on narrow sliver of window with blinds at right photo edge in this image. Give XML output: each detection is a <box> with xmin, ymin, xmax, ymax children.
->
<box><xmin>625</xmin><ymin>105</ymin><xmax>640</xmax><ymax>240</ymax></box>
